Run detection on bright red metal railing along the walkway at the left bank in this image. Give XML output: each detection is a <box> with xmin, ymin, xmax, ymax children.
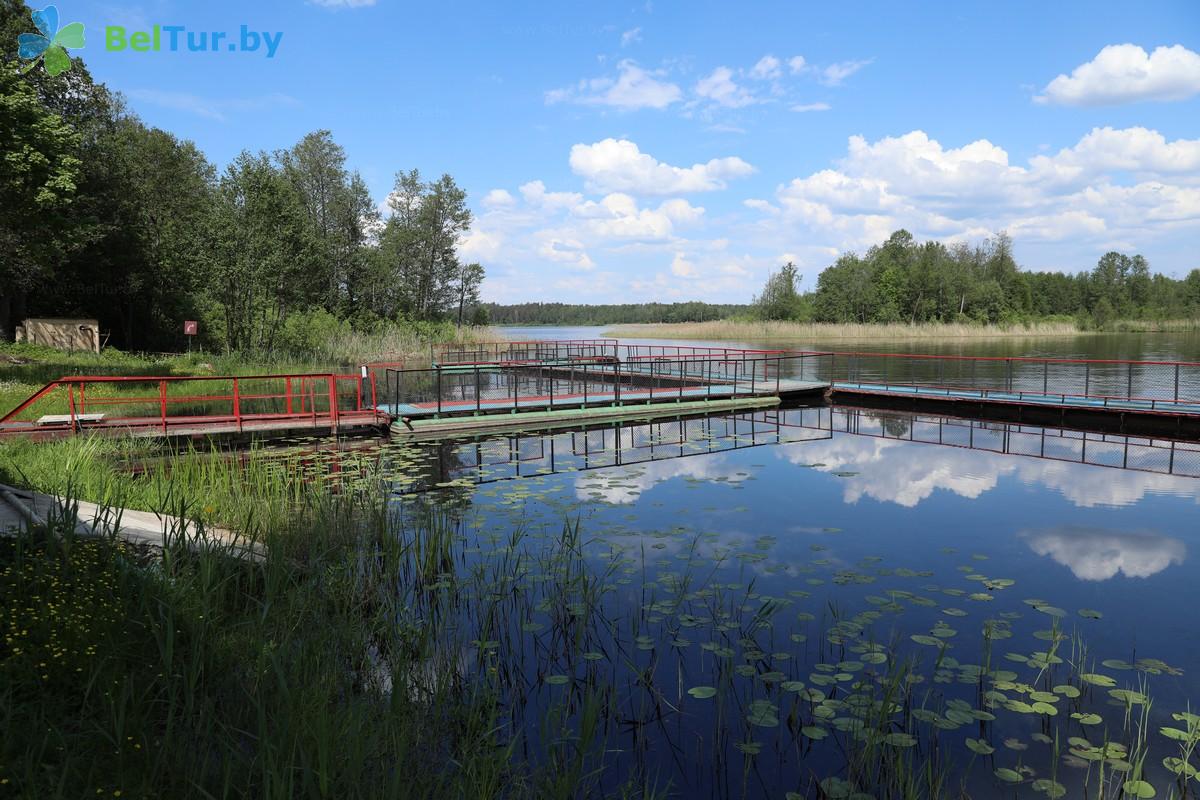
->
<box><xmin>0</xmin><ymin>373</ymin><xmax>386</xmax><ymax>433</ymax></box>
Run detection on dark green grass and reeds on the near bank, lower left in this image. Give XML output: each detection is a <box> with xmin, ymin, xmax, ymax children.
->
<box><xmin>0</xmin><ymin>494</ymin><xmax>528</xmax><ymax>798</ymax></box>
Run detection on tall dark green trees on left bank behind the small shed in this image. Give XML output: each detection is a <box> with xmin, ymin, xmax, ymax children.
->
<box><xmin>0</xmin><ymin>0</ymin><xmax>484</xmax><ymax>350</ymax></box>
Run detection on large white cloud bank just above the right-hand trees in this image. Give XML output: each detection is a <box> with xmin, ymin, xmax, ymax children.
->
<box><xmin>748</xmin><ymin>127</ymin><xmax>1200</xmax><ymax>249</ymax></box>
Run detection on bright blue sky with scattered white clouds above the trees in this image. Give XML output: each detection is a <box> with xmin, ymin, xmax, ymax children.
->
<box><xmin>54</xmin><ymin>0</ymin><xmax>1200</xmax><ymax>302</ymax></box>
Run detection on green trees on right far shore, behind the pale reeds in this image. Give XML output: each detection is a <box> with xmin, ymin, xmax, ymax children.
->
<box><xmin>754</xmin><ymin>230</ymin><xmax>1200</xmax><ymax>327</ymax></box>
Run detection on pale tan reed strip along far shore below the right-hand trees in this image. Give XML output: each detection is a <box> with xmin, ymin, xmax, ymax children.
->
<box><xmin>604</xmin><ymin>319</ymin><xmax>1082</xmax><ymax>342</ymax></box>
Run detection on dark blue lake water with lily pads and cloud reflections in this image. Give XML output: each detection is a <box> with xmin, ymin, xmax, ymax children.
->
<box><xmin>367</xmin><ymin>329</ymin><xmax>1200</xmax><ymax>799</ymax></box>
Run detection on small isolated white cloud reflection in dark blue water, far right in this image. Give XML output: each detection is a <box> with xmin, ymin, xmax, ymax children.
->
<box><xmin>1021</xmin><ymin>525</ymin><xmax>1187</xmax><ymax>581</ymax></box>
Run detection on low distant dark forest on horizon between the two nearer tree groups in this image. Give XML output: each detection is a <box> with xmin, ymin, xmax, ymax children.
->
<box><xmin>481</xmin><ymin>301</ymin><xmax>750</xmax><ymax>325</ymax></box>
